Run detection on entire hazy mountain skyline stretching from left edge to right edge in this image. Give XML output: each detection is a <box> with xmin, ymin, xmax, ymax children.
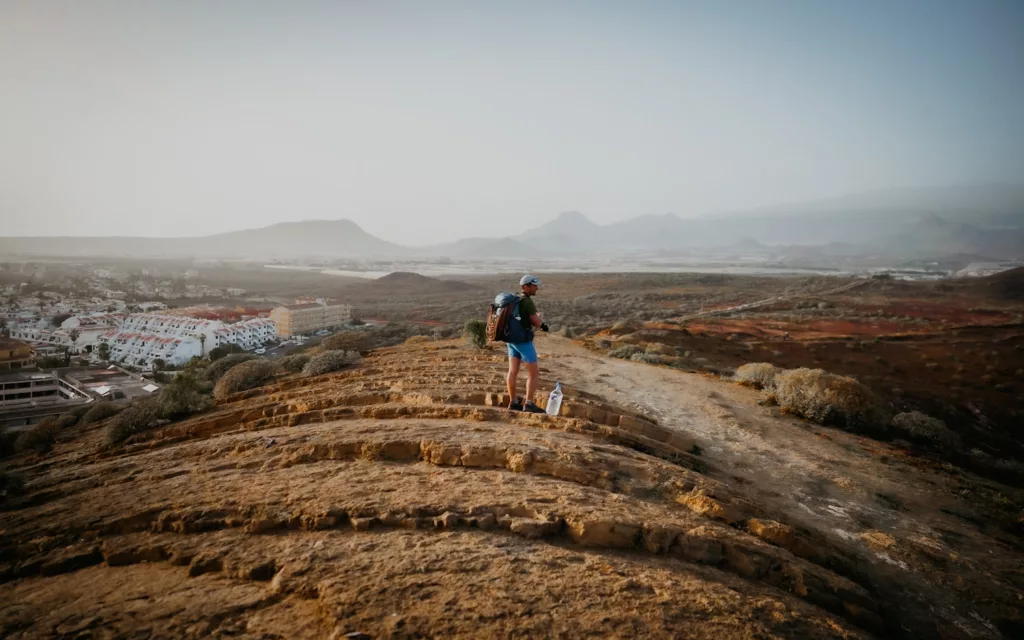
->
<box><xmin>0</xmin><ymin>185</ymin><xmax>1024</xmax><ymax>259</ymax></box>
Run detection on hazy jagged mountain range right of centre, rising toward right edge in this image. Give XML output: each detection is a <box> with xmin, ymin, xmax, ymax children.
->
<box><xmin>499</xmin><ymin>184</ymin><xmax>1024</xmax><ymax>257</ymax></box>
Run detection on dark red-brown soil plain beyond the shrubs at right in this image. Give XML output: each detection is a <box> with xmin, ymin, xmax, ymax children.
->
<box><xmin>590</xmin><ymin>282</ymin><xmax>1024</xmax><ymax>466</ymax></box>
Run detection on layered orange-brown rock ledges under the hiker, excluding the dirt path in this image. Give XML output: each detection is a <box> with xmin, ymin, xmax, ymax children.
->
<box><xmin>0</xmin><ymin>341</ymin><xmax>1019</xmax><ymax>638</ymax></box>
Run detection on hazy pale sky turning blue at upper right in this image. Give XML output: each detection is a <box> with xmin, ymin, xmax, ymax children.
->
<box><xmin>0</xmin><ymin>0</ymin><xmax>1024</xmax><ymax>244</ymax></box>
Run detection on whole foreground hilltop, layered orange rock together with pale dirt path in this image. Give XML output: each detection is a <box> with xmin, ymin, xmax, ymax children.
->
<box><xmin>0</xmin><ymin>336</ymin><xmax>1024</xmax><ymax>639</ymax></box>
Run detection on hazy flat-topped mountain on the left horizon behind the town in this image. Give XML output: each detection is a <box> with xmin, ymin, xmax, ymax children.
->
<box><xmin>0</xmin><ymin>220</ymin><xmax>408</xmax><ymax>260</ymax></box>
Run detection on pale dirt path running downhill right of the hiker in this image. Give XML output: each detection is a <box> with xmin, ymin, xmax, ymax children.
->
<box><xmin>539</xmin><ymin>337</ymin><xmax>1024</xmax><ymax>637</ymax></box>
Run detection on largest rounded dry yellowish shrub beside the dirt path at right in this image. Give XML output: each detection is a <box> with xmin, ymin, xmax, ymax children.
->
<box><xmin>774</xmin><ymin>369</ymin><xmax>889</xmax><ymax>432</ymax></box>
